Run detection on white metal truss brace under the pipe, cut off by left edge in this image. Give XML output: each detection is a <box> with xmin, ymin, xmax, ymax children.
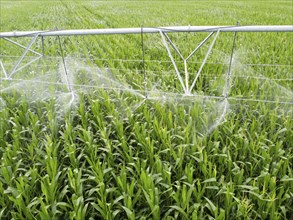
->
<box><xmin>0</xmin><ymin>34</ymin><xmax>43</xmax><ymax>79</ymax></box>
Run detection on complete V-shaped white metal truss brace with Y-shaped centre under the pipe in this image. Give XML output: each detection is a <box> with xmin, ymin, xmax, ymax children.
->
<box><xmin>160</xmin><ymin>29</ymin><xmax>220</xmax><ymax>95</ymax></box>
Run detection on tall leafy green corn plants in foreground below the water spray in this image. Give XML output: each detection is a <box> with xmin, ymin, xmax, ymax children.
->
<box><xmin>1</xmin><ymin>91</ymin><xmax>293</xmax><ymax>219</ymax></box>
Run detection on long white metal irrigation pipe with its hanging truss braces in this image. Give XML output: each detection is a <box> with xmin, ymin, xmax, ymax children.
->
<box><xmin>0</xmin><ymin>25</ymin><xmax>293</xmax><ymax>103</ymax></box>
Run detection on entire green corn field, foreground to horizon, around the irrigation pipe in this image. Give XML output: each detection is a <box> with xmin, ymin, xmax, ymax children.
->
<box><xmin>0</xmin><ymin>0</ymin><xmax>293</xmax><ymax>220</ymax></box>
